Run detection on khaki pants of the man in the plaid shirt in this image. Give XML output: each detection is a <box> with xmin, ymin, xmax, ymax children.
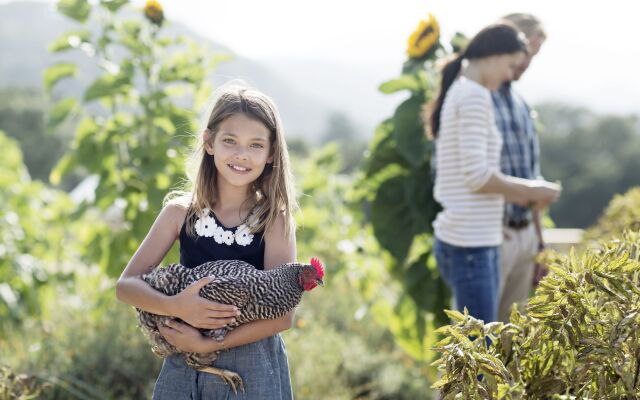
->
<box><xmin>498</xmin><ymin>223</ymin><xmax>538</xmax><ymax>322</ymax></box>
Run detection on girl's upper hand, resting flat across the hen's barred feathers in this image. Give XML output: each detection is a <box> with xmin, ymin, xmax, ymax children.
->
<box><xmin>172</xmin><ymin>277</ymin><xmax>240</xmax><ymax>329</ymax></box>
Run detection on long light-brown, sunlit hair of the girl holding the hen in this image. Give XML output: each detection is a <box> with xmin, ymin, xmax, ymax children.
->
<box><xmin>165</xmin><ymin>82</ymin><xmax>298</xmax><ymax>238</ymax></box>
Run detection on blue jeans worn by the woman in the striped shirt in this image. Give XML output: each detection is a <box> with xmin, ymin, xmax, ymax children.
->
<box><xmin>433</xmin><ymin>237</ymin><xmax>500</xmax><ymax>323</ymax></box>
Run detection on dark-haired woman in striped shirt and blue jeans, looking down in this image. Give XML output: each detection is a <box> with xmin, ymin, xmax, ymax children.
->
<box><xmin>430</xmin><ymin>24</ymin><xmax>559</xmax><ymax>322</ymax></box>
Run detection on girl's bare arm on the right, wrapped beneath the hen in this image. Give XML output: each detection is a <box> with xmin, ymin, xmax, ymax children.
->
<box><xmin>160</xmin><ymin>211</ymin><xmax>296</xmax><ymax>353</ymax></box>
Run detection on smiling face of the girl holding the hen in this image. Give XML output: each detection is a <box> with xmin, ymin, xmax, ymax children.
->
<box><xmin>204</xmin><ymin>114</ymin><xmax>273</xmax><ymax>192</ymax></box>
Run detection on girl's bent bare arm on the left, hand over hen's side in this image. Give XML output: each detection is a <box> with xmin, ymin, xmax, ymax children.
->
<box><xmin>116</xmin><ymin>205</ymin><xmax>236</xmax><ymax>329</ymax></box>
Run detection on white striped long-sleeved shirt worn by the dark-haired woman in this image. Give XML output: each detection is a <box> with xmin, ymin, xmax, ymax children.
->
<box><xmin>433</xmin><ymin>76</ymin><xmax>504</xmax><ymax>247</ymax></box>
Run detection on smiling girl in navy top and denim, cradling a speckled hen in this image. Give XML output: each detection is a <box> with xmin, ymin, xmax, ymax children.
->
<box><xmin>116</xmin><ymin>85</ymin><xmax>297</xmax><ymax>399</ymax></box>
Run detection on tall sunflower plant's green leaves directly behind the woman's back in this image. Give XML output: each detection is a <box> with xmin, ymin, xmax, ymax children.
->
<box><xmin>358</xmin><ymin>21</ymin><xmax>458</xmax><ymax>360</ymax></box>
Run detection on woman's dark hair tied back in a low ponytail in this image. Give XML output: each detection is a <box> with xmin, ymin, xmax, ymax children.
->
<box><xmin>430</xmin><ymin>23</ymin><xmax>527</xmax><ymax>138</ymax></box>
